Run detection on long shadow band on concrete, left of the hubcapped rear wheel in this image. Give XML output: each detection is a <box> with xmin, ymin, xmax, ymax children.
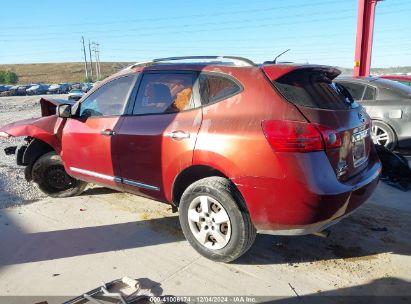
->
<box><xmin>0</xmin><ymin>213</ymin><xmax>184</xmax><ymax>266</ymax></box>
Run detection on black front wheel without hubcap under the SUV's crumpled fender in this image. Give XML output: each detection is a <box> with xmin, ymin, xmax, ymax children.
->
<box><xmin>32</xmin><ymin>151</ymin><xmax>87</xmax><ymax>197</ymax></box>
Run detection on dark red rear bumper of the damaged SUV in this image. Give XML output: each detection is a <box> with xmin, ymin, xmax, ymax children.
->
<box><xmin>234</xmin><ymin>148</ymin><xmax>381</xmax><ymax>235</ymax></box>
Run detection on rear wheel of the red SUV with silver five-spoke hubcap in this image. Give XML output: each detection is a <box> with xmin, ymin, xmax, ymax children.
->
<box><xmin>179</xmin><ymin>177</ymin><xmax>256</xmax><ymax>263</ymax></box>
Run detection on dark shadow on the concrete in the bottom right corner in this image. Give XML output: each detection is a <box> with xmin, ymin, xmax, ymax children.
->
<box><xmin>256</xmin><ymin>277</ymin><xmax>411</xmax><ymax>304</ymax></box>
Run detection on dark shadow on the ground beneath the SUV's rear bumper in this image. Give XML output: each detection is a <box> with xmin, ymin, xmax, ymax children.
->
<box><xmin>234</xmin><ymin>205</ymin><xmax>411</xmax><ymax>267</ymax></box>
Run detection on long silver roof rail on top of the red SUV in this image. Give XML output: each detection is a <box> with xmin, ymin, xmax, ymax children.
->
<box><xmin>124</xmin><ymin>56</ymin><xmax>256</xmax><ymax>70</ymax></box>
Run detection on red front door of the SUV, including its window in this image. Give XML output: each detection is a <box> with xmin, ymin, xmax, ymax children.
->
<box><xmin>61</xmin><ymin>75</ymin><xmax>136</xmax><ymax>190</ymax></box>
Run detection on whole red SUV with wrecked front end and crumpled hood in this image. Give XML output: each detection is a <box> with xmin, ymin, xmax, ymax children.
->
<box><xmin>0</xmin><ymin>56</ymin><xmax>381</xmax><ymax>262</ymax></box>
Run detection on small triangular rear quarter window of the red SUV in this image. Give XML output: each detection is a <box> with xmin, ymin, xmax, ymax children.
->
<box><xmin>200</xmin><ymin>74</ymin><xmax>242</xmax><ymax>105</ymax></box>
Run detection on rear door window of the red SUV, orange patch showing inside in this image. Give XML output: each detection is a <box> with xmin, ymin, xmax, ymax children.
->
<box><xmin>133</xmin><ymin>72</ymin><xmax>195</xmax><ymax>115</ymax></box>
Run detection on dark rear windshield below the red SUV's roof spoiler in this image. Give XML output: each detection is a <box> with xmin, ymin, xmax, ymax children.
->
<box><xmin>273</xmin><ymin>70</ymin><xmax>353</xmax><ymax>110</ymax></box>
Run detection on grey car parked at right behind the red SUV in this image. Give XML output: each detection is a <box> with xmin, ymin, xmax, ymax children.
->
<box><xmin>334</xmin><ymin>77</ymin><xmax>411</xmax><ymax>150</ymax></box>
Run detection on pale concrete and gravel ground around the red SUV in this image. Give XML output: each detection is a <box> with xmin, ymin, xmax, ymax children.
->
<box><xmin>0</xmin><ymin>96</ymin><xmax>411</xmax><ymax>303</ymax></box>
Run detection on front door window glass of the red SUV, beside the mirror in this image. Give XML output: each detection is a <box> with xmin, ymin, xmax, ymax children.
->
<box><xmin>80</xmin><ymin>75</ymin><xmax>135</xmax><ymax>117</ymax></box>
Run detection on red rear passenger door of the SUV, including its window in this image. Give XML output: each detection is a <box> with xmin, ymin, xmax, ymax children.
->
<box><xmin>115</xmin><ymin>71</ymin><xmax>202</xmax><ymax>201</ymax></box>
